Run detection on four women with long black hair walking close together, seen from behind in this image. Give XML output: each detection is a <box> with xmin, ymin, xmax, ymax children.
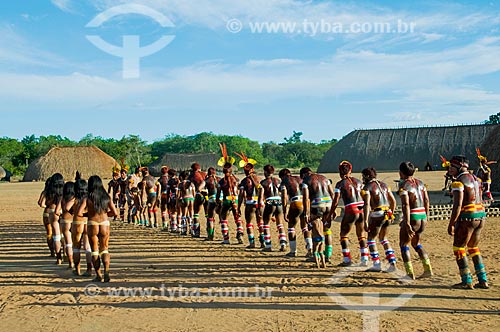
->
<box><xmin>38</xmin><ymin>172</ymin><xmax>118</xmax><ymax>282</ymax></box>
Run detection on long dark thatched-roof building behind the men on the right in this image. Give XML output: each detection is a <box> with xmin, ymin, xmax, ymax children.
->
<box><xmin>318</xmin><ymin>125</ymin><xmax>496</xmax><ymax>173</ymax></box>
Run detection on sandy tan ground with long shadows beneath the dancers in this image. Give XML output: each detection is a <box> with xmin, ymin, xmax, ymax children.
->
<box><xmin>0</xmin><ymin>172</ymin><xmax>500</xmax><ymax>331</ymax></box>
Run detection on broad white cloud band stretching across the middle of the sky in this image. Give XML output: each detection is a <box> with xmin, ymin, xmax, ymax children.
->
<box><xmin>0</xmin><ymin>38</ymin><xmax>500</xmax><ymax>116</ymax></box>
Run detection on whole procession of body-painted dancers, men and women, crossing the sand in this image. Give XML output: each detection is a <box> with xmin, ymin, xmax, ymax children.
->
<box><xmin>39</xmin><ymin>144</ymin><xmax>489</xmax><ymax>289</ymax></box>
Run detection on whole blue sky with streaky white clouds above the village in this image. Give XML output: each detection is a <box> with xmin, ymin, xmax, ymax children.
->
<box><xmin>0</xmin><ymin>0</ymin><xmax>500</xmax><ymax>142</ymax></box>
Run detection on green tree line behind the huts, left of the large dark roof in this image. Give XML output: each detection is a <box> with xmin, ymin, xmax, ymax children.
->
<box><xmin>0</xmin><ymin>131</ymin><xmax>337</xmax><ymax>176</ymax></box>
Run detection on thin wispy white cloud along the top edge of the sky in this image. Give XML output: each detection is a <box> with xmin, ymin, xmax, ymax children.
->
<box><xmin>83</xmin><ymin>0</ymin><xmax>500</xmax><ymax>38</ymax></box>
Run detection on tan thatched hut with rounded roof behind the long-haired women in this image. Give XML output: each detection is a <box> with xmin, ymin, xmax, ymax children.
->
<box><xmin>23</xmin><ymin>146</ymin><xmax>118</xmax><ymax>181</ymax></box>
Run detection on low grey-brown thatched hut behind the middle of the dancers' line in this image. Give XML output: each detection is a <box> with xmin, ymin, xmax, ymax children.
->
<box><xmin>149</xmin><ymin>153</ymin><xmax>220</xmax><ymax>176</ymax></box>
